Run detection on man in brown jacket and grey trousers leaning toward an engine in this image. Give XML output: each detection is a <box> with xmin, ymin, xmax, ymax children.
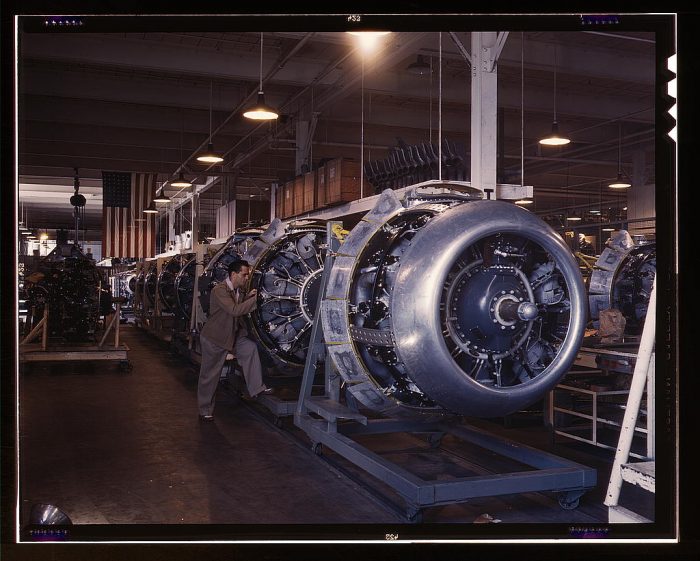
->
<box><xmin>197</xmin><ymin>260</ymin><xmax>272</xmax><ymax>421</ymax></box>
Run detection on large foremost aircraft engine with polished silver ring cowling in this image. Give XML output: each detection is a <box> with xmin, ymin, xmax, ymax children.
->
<box><xmin>321</xmin><ymin>187</ymin><xmax>587</xmax><ymax>417</ymax></box>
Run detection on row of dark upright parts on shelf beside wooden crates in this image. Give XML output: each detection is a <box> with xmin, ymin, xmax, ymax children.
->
<box><xmin>364</xmin><ymin>138</ymin><xmax>469</xmax><ymax>193</ymax></box>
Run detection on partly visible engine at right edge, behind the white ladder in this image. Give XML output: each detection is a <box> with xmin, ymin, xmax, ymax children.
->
<box><xmin>588</xmin><ymin>230</ymin><xmax>656</xmax><ymax>335</ymax></box>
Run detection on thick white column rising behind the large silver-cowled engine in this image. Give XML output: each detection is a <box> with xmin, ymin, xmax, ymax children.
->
<box><xmin>471</xmin><ymin>31</ymin><xmax>498</xmax><ymax>198</ymax></box>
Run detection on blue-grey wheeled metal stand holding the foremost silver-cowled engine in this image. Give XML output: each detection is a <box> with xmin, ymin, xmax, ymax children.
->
<box><xmin>294</xmin><ymin>222</ymin><xmax>597</xmax><ymax>522</ymax></box>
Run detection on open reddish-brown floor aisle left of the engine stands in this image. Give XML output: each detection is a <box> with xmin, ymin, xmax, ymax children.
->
<box><xmin>20</xmin><ymin>327</ymin><xmax>398</xmax><ymax>524</ymax></box>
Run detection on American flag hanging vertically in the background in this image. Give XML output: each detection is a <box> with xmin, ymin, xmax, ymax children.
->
<box><xmin>102</xmin><ymin>171</ymin><xmax>158</xmax><ymax>258</ymax></box>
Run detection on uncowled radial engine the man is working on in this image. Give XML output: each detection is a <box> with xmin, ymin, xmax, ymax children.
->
<box><xmin>244</xmin><ymin>219</ymin><xmax>326</xmax><ymax>367</ymax></box>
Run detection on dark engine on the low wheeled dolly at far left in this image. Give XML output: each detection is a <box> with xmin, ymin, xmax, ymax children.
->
<box><xmin>25</xmin><ymin>243</ymin><xmax>102</xmax><ymax>342</ymax></box>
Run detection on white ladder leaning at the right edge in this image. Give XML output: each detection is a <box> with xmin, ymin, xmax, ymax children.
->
<box><xmin>604</xmin><ymin>279</ymin><xmax>656</xmax><ymax>523</ymax></box>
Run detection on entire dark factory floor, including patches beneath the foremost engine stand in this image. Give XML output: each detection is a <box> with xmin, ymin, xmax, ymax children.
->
<box><xmin>19</xmin><ymin>326</ymin><xmax>656</xmax><ymax>537</ymax></box>
